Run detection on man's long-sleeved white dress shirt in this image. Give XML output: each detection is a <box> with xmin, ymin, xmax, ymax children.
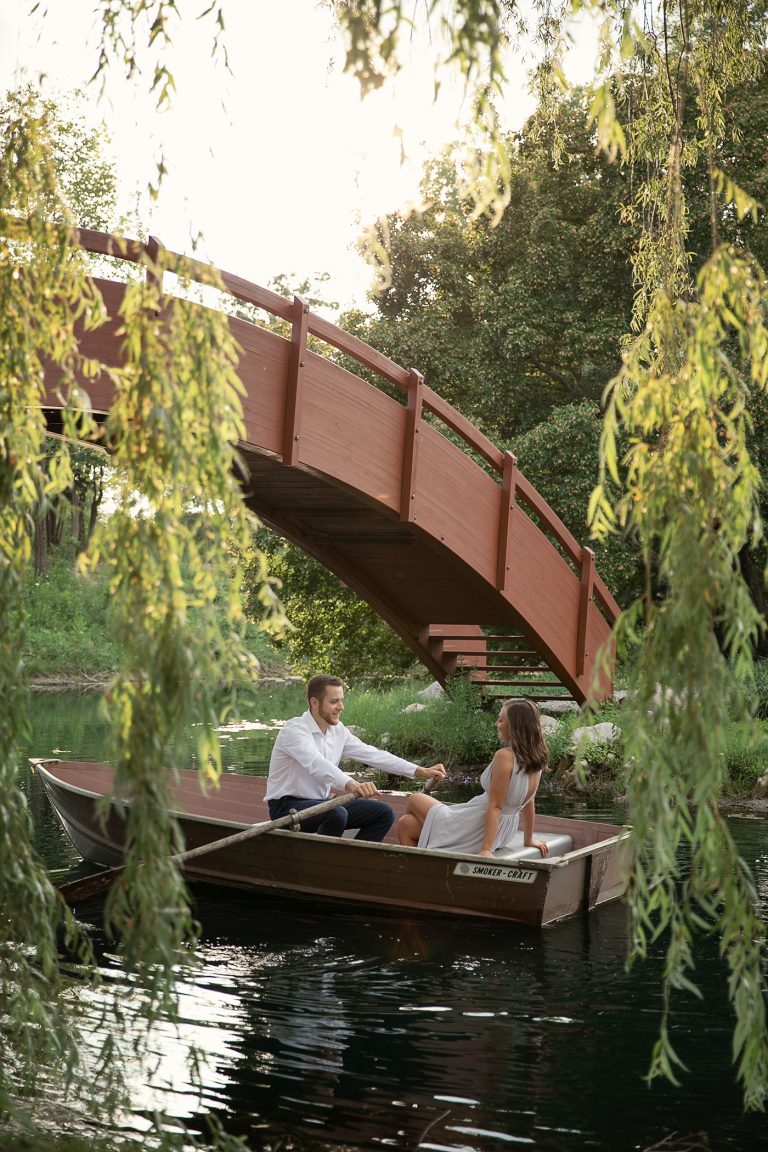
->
<box><xmin>264</xmin><ymin>711</ymin><xmax>417</xmax><ymax>801</ymax></box>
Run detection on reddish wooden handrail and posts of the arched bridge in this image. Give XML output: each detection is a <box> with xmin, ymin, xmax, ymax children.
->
<box><xmin>43</xmin><ymin>228</ymin><xmax>621</xmax><ymax>658</ymax></box>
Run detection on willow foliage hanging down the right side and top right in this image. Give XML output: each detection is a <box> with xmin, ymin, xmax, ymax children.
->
<box><xmin>335</xmin><ymin>0</ymin><xmax>768</xmax><ymax>1108</ymax></box>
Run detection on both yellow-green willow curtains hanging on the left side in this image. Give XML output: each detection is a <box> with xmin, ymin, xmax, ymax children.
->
<box><xmin>0</xmin><ymin>36</ymin><xmax>274</xmax><ymax>1143</ymax></box>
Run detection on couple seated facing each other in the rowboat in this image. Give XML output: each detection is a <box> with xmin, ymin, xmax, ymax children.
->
<box><xmin>265</xmin><ymin>676</ymin><xmax>547</xmax><ymax>856</ymax></box>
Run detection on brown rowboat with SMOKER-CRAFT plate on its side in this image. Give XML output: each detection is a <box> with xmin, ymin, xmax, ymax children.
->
<box><xmin>32</xmin><ymin>760</ymin><xmax>629</xmax><ymax>926</ymax></box>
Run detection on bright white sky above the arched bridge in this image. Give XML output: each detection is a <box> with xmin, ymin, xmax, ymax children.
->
<box><xmin>0</xmin><ymin>0</ymin><xmax>598</xmax><ymax>309</ymax></box>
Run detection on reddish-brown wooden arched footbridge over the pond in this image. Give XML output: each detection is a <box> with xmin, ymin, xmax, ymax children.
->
<box><xmin>40</xmin><ymin>229</ymin><xmax>618</xmax><ymax>702</ymax></box>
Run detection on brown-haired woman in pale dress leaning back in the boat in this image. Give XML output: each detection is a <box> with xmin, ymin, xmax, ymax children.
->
<box><xmin>397</xmin><ymin>698</ymin><xmax>548</xmax><ymax>856</ymax></box>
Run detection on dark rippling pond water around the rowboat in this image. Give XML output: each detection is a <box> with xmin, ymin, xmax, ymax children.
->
<box><xmin>19</xmin><ymin>689</ymin><xmax>768</xmax><ymax>1152</ymax></box>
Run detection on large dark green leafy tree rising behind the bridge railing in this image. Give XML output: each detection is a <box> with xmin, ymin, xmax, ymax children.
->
<box><xmin>344</xmin><ymin>91</ymin><xmax>632</xmax><ymax>442</ymax></box>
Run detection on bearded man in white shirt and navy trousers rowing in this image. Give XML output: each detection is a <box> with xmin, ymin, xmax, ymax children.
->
<box><xmin>265</xmin><ymin>676</ymin><xmax>446</xmax><ymax>841</ymax></box>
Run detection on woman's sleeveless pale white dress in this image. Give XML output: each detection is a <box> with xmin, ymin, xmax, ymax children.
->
<box><xmin>419</xmin><ymin>757</ymin><xmax>531</xmax><ymax>852</ymax></box>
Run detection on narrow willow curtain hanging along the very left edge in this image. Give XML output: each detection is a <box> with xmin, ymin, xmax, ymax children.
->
<box><xmin>0</xmin><ymin>94</ymin><xmax>133</xmax><ymax>1116</ymax></box>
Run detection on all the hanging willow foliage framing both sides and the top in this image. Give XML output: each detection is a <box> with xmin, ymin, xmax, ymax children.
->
<box><xmin>0</xmin><ymin>0</ymin><xmax>768</xmax><ymax>1142</ymax></box>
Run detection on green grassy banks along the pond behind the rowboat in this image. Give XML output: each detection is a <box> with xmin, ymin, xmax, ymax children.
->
<box><xmin>23</xmin><ymin>551</ymin><xmax>768</xmax><ymax>799</ymax></box>
